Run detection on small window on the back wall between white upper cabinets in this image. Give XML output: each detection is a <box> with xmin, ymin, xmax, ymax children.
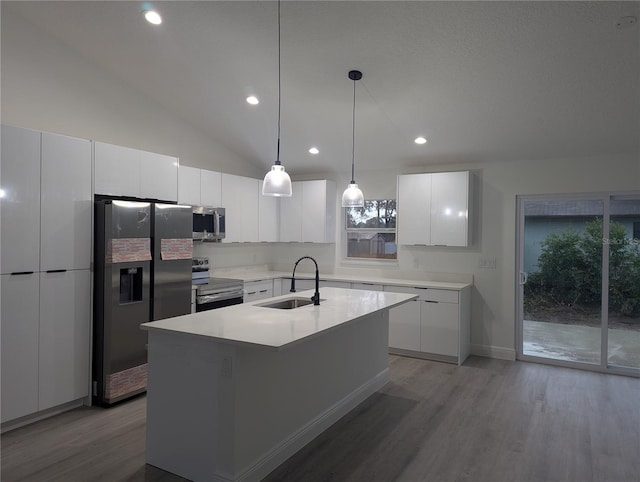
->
<box><xmin>346</xmin><ymin>199</ymin><xmax>397</xmax><ymax>259</ymax></box>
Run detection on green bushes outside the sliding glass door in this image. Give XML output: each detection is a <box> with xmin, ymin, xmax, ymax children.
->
<box><xmin>524</xmin><ymin>218</ymin><xmax>640</xmax><ymax>317</ymax></box>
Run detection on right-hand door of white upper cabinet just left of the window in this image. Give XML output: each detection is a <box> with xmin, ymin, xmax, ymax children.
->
<box><xmin>301</xmin><ymin>180</ymin><xmax>336</xmax><ymax>243</ymax></box>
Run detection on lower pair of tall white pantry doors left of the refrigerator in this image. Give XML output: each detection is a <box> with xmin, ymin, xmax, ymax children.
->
<box><xmin>1</xmin><ymin>269</ymin><xmax>91</xmax><ymax>423</ymax></box>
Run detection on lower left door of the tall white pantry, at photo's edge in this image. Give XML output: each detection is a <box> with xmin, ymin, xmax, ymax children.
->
<box><xmin>0</xmin><ymin>274</ymin><xmax>39</xmax><ymax>422</ymax></box>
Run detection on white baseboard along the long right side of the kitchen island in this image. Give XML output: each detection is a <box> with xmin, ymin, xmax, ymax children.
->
<box><xmin>236</xmin><ymin>368</ymin><xmax>389</xmax><ymax>481</ymax></box>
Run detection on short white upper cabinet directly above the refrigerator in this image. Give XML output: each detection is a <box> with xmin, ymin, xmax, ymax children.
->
<box><xmin>94</xmin><ymin>142</ymin><xmax>178</xmax><ymax>201</ymax></box>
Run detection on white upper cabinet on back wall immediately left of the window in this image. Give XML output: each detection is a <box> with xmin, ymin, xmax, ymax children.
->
<box><xmin>280</xmin><ymin>180</ymin><xmax>336</xmax><ymax>243</ymax></box>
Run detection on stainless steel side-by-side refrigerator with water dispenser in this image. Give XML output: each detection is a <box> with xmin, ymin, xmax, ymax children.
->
<box><xmin>93</xmin><ymin>199</ymin><xmax>193</xmax><ymax>405</ymax></box>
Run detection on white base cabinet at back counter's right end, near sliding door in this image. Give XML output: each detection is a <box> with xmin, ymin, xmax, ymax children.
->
<box><xmin>384</xmin><ymin>285</ymin><xmax>471</xmax><ymax>365</ymax></box>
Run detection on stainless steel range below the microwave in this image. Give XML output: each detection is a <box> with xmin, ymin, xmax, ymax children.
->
<box><xmin>192</xmin><ymin>258</ymin><xmax>244</xmax><ymax>312</ymax></box>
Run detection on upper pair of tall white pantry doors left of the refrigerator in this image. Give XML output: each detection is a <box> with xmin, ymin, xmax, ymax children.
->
<box><xmin>1</xmin><ymin>126</ymin><xmax>92</xmax><ymax>273</ymax></box>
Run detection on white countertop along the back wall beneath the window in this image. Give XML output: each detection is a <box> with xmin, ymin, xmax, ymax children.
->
<box><xmin>211</xmin><ymin>268</ymin><xmax>472</xmax><ymax>291</ymax></box>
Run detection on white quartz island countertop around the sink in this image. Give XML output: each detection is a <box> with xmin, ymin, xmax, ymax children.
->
<box><xmin>141</xmin><ymin>288</ymin><xmax>416</xmax><ymax>350</ymax></box>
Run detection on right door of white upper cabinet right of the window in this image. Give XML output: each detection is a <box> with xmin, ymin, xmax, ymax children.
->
<box><xmin>431</xmin><ymin>171</ymin><xmax>469</xmax><ymax>246</ymax></box>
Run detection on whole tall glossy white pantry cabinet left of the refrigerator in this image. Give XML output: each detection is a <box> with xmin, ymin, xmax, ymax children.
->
<box><xmin>0</xmin><ymin>126</ymin><xmax>92</xmax><ymax>423</ymax></box>
